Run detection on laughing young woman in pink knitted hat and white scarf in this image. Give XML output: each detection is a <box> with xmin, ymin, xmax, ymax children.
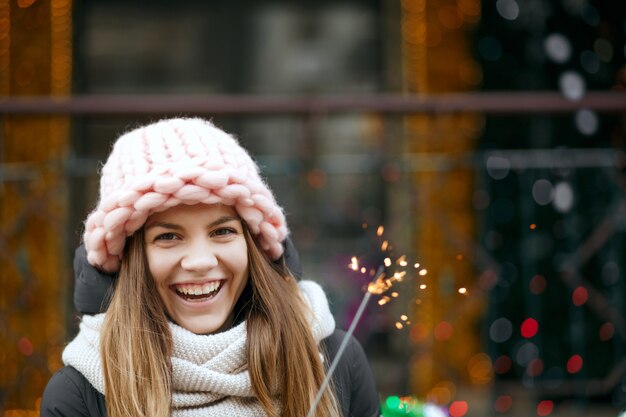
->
<box><xmin>41</xmin><ymin>119</ymin><xmax>378</xmax><ymax>417</ymax></box>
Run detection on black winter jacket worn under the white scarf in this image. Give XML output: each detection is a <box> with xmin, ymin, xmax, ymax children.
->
<box><xmin>41</xmin><ymin>239</ymin><xmax>380</xmax><ymax>417</ymax></box>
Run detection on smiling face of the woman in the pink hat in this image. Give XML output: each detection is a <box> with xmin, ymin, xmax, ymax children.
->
<box><xmin>144</xmin><ymin>204</ymin><xmax>248</xmax><ymax>334</ymax></box>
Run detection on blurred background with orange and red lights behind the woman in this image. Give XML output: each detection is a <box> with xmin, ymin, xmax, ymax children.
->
<box><xmin>0</xmin><ymin>0</ymin><xmax>626</xmax><ymax>417</ymax></box>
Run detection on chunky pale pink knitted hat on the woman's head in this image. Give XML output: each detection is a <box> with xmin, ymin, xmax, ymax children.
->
<box><xmin>84</xmin><ymin>119</ymin><xmax>289</xmax><ymax>272</ymax></box>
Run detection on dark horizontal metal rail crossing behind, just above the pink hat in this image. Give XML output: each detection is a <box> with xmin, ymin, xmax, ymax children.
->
<box><xmin>0</xmin><ymin>90</ymin><xmax>626</xmax><ymax>115</ymax></box>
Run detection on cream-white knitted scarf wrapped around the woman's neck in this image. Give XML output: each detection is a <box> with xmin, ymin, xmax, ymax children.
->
<box><xmin>63</xmin><ymin>281</ymin><xmax>335</xmax><ymax>417</ymax></box>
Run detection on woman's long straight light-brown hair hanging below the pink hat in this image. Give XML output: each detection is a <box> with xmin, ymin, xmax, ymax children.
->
<box><xmin>101</xmin><ymin>223</ymin><xmax>339</xmax><ymax>417</ymax></box>
